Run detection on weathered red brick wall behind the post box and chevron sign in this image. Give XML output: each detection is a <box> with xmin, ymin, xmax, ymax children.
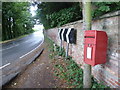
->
<box><xmin>46</xmin><ymin>11</ymin><xmax>120</xmax><ymax>88</ymax></box>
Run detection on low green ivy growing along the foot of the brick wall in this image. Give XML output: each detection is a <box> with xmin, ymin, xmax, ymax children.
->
<box><xmin>45</xmin><ymin>37</ymin><xmax>109</xmax><ymax>88</ymax></box>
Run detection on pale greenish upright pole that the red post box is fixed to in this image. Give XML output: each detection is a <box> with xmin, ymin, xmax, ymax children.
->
<box><xmin>82</xmin><ymin>0</ymin><xmax>92</xmax><ymax>88</ymax></box>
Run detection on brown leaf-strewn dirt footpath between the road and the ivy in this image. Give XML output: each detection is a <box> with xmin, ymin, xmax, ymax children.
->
<box><xmin>3</xmin><ymin>42</ymin><xmax>67</xmax><ymax>89</ymax></box>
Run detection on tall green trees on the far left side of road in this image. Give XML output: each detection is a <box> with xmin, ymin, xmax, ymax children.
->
<box><xmin>2</xmin><ymin>2</ymin><xmax>35</xmax><ymax>40</ymax></box>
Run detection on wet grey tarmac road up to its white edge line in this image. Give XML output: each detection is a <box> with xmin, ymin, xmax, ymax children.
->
<box><xmin>0</xmin><ymin>30</ymin><xmax>44</xmax><ymax>69</ymax></box>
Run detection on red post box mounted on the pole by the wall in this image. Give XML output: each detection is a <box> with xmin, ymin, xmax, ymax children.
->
<box><xmin>84</xmin><ymin>30</ymin><xmax>108</xmax><ymax>66</ymax></box>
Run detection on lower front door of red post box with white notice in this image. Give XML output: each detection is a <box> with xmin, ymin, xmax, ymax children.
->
<box><xmin>84</xmin><ymin>44</ymin><xmax>95</xmax><ymax>66</ymax></box>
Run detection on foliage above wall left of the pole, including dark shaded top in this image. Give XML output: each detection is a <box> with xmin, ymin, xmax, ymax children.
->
<box><xmin>37</xmin><ymin>2</ymin><xmax>82</xmax><ymax>29</ymax></box>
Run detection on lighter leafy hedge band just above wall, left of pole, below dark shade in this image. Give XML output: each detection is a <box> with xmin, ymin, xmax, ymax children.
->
<box><xmin>46</xmin><ymin>6</ymin><xmax>82</xmax><ymax>28</ymax></box>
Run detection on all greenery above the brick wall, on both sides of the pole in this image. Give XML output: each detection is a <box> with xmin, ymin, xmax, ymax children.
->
<box><xmin>37</xmin><ymin>2</ymin><xmax>120</xmax><ymax>29</ymax></box>
